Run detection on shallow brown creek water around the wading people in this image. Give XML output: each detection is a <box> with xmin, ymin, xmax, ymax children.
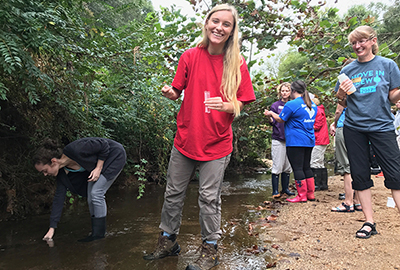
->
<box><xmin>0</xmin><ymin>174</ymin><xmax>288</xmax><ymax>270</ymax></box>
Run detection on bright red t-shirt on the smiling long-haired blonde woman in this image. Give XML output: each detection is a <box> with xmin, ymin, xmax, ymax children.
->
<box><xmin>172</xmin><ymin>47</ymin><xmax>255</xmax><ymax>161</ymax></box>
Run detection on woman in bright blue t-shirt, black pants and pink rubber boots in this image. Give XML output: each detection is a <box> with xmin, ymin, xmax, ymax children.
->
<box><xmin>264</xmin><ymin>80</ymin><xmax>318</xmax><ymax>203</ymax></box>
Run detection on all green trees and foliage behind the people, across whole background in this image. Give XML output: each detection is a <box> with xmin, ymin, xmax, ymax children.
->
<box><xmin>0</xmin><ymin>0</ymin><xmax>398</xmax><ymax>216</ymax></box>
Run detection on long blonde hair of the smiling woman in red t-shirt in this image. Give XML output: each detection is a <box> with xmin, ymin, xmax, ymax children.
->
<box><xmin>197</xmin><ymin>4</ymin><xmax>243</xmax><ymax>116</ymax></box>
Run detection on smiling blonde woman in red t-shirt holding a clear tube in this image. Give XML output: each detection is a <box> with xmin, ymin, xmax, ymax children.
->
<box><xmin>144</xmin><ymin>4</ymin><xmax>255</xmax><ymax>270</ymax></box>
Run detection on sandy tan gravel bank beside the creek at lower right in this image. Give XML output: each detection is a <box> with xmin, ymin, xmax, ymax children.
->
<box><xmin>259</xmin><ymin>175</ymin><xmax>400</xmax><ymax>270</ymax></box>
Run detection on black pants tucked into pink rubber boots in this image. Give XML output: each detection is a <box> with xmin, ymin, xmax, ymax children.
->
<box><xmin>286</xmin><ymin>146</ymin><xmax>314</xmax><ymax>180</ymax></box>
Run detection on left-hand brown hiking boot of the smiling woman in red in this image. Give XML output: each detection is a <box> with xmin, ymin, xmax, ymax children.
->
<box><xmin>143</xmin><ymin>232</ymin><xmax>181</xmax><ymax>260</ymax></box>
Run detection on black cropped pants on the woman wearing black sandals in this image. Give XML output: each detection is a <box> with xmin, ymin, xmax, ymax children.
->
<box><xmin>343</xmin><ymin>126</ymin><xmax>400</xmax><ymax>190</ymax></box>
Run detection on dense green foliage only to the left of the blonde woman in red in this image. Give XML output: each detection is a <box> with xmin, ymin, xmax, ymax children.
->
<box><xmin>0</xmin><ymin>0</ymin><xmax>196</xmax><ymax>215</ymax></box>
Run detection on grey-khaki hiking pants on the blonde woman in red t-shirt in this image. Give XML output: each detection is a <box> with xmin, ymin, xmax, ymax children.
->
<box><xmin>160</xmin><ymin>147</ymin><xmax>231</xmax><ymax>241</ymax></box>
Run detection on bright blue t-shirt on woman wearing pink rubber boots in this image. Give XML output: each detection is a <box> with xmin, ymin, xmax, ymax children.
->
<box><xmin>279</xmin><ymin>97</ymin><xmax>318</xmax><ymax>147</ymax></box>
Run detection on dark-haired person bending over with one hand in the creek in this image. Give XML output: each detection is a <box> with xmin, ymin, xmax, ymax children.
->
<box><xmin>33</xmin><ymin>137</ymin><xmax>126</xmax><ymax>242</ymax></box>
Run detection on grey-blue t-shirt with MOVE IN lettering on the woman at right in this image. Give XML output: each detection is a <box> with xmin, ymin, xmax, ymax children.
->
<box><xmin>335</xmin><ymin>56</ymin><xmax>400</xmax><ymax>132</ymax></box>
